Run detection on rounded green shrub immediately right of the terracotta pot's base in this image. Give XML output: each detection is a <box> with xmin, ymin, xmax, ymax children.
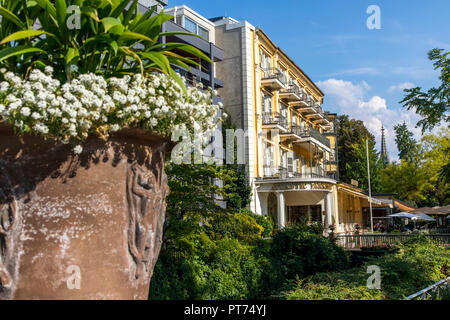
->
<box><xmin>150</xmin><ymin>235</ymin><xmax>270</xmax><ymax>300</ymax></box>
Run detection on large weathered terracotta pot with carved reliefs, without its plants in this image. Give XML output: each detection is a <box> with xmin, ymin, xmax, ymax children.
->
<box><xmin>0</xmin><ymin>124</ymin><xmax>171</xmax><ymax>299</ymax></box>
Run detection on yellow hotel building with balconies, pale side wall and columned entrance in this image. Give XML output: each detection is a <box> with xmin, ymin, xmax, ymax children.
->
<box><xmin>210</xmin><ymin>17</ymin><xmax>338</xmax><ymax>228</ymax></box>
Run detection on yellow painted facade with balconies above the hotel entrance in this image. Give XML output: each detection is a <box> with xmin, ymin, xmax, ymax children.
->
<box><xmin>253</xmin><ymin>29</ymin><xmax>337</xmax><ymax>178</ymax></box>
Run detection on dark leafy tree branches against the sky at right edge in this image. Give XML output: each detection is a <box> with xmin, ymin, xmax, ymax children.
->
<box><xmin>401</xmin><ymin>49</ymin><xmax>450</xmax><ymax>132</ymax></box>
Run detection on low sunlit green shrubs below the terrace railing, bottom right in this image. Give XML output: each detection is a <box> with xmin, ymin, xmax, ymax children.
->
<box><xmin>283</xmin><ymin>236</ymin><xmax>450</xmax><ymax>300</ymax></box>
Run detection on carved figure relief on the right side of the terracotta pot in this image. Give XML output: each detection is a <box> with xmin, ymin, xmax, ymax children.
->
<box><xmin>127</xmin><ymin>163</ymin><xmax>167</xmax><ymax>280</ymax></box>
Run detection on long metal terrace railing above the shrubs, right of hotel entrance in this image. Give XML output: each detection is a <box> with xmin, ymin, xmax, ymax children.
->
<box><xmin>336</xmin><ymin>234</ymin><xmax>450</xmax><ymax>249</ymax></box>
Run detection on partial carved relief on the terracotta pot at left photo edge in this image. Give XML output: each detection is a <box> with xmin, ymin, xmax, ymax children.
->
<box><xmin>0</xmin><ymin>165</ymin><xmax>21</xmax><ymax>299</ymax></box>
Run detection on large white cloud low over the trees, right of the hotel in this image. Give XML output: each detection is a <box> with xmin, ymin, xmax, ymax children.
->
<box><xmin>317</xmin><ymin>79</ymin><xmax>421</xmax><ymax>161</ymax></box>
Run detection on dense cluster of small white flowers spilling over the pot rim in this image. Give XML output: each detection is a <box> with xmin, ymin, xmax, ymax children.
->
<box><xmin>0</xmin><ymin>67</ymin><xmax>221</xmax><ymax>153</ymax></box>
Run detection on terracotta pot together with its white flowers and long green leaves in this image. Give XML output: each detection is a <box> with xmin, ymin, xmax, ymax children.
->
<box><xmin>0</xmin><ymin>0</ymin><xmax>219</xmax><ymax>299</ymax></box>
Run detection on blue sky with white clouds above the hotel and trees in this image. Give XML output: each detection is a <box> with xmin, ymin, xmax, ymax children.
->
<box><xmin>169</xmin><ymin>0</ymin><xmax>450</xmax><ymax>160</ymax></box>
